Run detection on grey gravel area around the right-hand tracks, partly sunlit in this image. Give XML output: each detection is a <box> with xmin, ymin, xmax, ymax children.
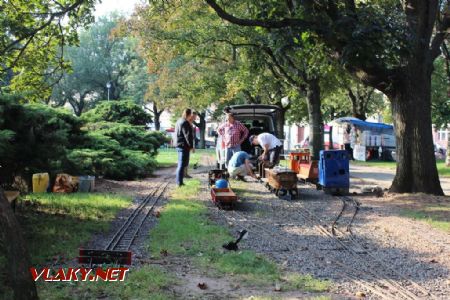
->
<box><xmin>205</xmin><ymin>170</ymin><xmax>450</xmax><ymax>299</ymax></box>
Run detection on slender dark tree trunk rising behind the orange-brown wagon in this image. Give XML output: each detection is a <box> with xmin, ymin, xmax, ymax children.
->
<box><xmin>306</xmin><ymin>79</ymin><xmax>323</xmax><ymax>160</ymax></box>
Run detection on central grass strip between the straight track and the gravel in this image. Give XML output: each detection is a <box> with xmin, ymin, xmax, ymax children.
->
<box><xmin>149</xmin><ymin>180</ymin><xmax>329</xmax><ymax>292</ymax></box>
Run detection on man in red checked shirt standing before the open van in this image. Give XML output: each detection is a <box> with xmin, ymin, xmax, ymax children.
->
<box><xmin>217</xmin><ymin>113</ymin><xmax>248</xmax><ymax>166</ymax></box>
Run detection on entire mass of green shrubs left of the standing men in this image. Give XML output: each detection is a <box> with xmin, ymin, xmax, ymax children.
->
<box><xmin>0</xmin><ymin>96</ymin><xmax>167</xmax><ymax>184</ymax></box>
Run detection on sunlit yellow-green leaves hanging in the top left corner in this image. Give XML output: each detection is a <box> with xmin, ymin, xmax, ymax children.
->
<box><xmin>0</xmin><ymin>0</ymin><xmax>96</xmax><ymax>101</ymax></box>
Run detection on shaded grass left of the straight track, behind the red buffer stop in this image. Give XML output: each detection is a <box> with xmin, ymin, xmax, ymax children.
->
<box><xmin>18</xmin><ymin>193</ymin><xmax>131</xmax><ymax>265</ymax></box>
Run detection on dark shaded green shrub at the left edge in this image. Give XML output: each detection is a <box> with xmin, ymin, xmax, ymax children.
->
<box><xmin>0</xmin><ymin>97</ymin><xmax>81</xmax><ymax>183</ymax></box>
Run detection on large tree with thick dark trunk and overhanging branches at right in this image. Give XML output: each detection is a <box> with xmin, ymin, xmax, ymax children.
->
<box><xmin>205</xmin><ymin>0</ymin><xmax>450</xmax><ymax>195</ymax></box>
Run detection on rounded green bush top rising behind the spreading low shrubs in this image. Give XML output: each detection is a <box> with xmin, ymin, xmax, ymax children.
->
<box><xmin>82</xmin><ymin>101</ymin><xmax>152</xmax><ymax>126</ymax></box>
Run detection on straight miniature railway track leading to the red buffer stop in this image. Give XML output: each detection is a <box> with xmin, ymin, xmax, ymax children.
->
<box><xmin>105</xmin><ymin>178</ymin><xmax>169</xmax><ymax>251</ymax></box>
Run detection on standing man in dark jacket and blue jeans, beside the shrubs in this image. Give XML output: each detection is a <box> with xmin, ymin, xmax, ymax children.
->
<box><xmin>175</xmin><ymin>108</ymin><xmax>194</xmax><ymax>186</ymax></box>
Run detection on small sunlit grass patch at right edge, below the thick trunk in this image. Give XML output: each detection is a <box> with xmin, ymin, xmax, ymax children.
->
<box><xmin>402</xmin><ymin>205</ymin><xmax>450</xmax><ymax>232</ymax></box>
